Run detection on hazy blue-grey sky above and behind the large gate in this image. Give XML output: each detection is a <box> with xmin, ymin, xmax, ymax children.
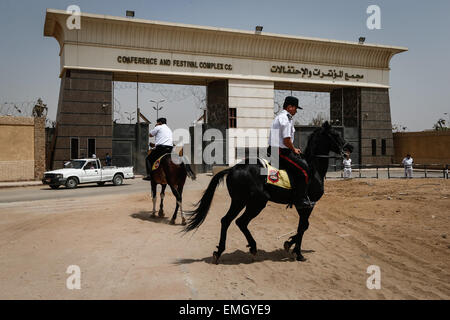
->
<box><xmin>0</xmin><ymin>0</ymin><xmax>450</xmax><ymax>131</ymax></box>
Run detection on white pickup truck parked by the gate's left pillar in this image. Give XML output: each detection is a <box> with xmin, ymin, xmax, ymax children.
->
<box><xmin>42</xmin><ymin>159</ymin><xmax>134</xmax><ymax>189</ymax></box>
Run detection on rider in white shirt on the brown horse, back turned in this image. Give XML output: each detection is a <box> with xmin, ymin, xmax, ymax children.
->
<box><xmin>143</xmin><ymin>118</ymin><xmax>173</xmax><ymax>181</ymax></box>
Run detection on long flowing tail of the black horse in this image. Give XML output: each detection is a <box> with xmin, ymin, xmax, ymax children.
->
<box><xmin>183</xmin><ymin>168</ymin><xmax>231</xmax><ymax>232</ymax></box>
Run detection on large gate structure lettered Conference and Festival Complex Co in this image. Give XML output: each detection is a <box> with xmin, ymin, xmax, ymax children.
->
<box><xmin>44</xmin><ymin>9</ymin><xmax>407</xmax><ymax>169</ymax></box>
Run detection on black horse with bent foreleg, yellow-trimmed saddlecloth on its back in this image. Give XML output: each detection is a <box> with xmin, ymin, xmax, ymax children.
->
<box><xmin>184</xmin><ymin>122</ymin><xmax>353</xmax><ymax>264</ymax></box>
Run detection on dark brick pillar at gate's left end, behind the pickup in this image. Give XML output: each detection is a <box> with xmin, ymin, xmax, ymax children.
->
<box><xmin>52</xmin><ymin>70</ymin><xmax>112</xmax><ymax>169</ymax></box>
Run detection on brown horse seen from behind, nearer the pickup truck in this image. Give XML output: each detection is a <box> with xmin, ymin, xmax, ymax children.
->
<box><xmin>149</xmin><ymin>149</ymin><xmax>196</xmax><ymax>225</ymax></box>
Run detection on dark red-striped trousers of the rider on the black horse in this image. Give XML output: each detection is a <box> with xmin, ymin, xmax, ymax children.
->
<box><xmin>268</xmin><ymin>147</ymin><xmax>309</xmax><ymax>197</ymax></box>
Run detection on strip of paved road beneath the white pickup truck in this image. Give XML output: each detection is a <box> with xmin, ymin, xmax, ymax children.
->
<box><xmin>0</xmin><ymin>174</ymin><xmax>211</xmax><ymax>203</ymax></box>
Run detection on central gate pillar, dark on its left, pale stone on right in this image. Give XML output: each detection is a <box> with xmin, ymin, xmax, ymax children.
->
<box><xmin>205</xmin><ymin>79</ymin><xmax>274</xmax><ymax>170</ymax></box>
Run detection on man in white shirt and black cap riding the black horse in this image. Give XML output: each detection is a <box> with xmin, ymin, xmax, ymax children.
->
<box><xmin>268</xmin><ymin>96</ymin><xmax>313</xmax><ymax>208</ymax></box>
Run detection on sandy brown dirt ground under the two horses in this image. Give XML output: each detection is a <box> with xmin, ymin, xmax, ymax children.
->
<box><xmin>0</xmin><ymin>177</ymin><xmax>450</xmax><ymax>299</ymax></box>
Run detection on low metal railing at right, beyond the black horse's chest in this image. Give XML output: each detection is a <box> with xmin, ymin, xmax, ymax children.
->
<box><xmin>326</xmin><ymin>164</ymin><xmax>449</xmax><ymax>179</ymax></box>
